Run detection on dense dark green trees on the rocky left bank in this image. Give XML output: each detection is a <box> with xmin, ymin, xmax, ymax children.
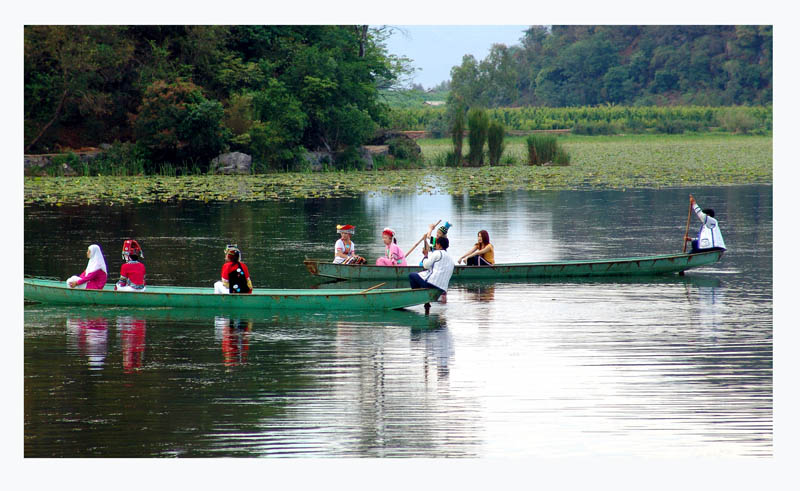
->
<box><xmin>24</xmin><ymin>25</ymin><xmax>408</xmax><ymax>169</ymax></box>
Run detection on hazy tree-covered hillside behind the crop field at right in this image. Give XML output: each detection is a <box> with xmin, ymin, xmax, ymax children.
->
<box><xmin>449</xmin><ymin>25</ymin><xmax>772</xmax><ymax>107</ymax></box>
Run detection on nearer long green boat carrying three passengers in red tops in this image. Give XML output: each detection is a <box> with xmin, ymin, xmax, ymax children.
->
<box><xmin>24</xmin><ymin>278</ymin><xmax>440</xmax><ymax>311</ymax></box>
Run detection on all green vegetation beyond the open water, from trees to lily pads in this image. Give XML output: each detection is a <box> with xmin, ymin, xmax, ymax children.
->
<box><xmin>23</xmin><ymin>25</ymin><xmax>773</xmax><ymax>206</ymax></box>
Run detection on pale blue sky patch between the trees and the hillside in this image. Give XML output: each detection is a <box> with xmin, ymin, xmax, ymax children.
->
<box><xmin>386</xmin><ymin>25</ymin><xmax>530</xmax><ymax>89</ymax></box>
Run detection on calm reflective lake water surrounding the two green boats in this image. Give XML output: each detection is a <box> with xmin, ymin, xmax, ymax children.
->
<box><xmin>24</xmin><ymin>186</ymin><xmax>773</xmax><ymax>458</ymax></box>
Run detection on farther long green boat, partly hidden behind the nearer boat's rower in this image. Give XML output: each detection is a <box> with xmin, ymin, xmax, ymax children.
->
<box><xmin>303</xmin><ymin>250</ymin><xmax>725</xmax><ymax>281</ymax></box>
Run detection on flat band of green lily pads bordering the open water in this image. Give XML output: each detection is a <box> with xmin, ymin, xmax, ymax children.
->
<box><xmin>24</xmin><ymin>135</ymin><xmax>772</xmax><ymax>206</ymax></box>
